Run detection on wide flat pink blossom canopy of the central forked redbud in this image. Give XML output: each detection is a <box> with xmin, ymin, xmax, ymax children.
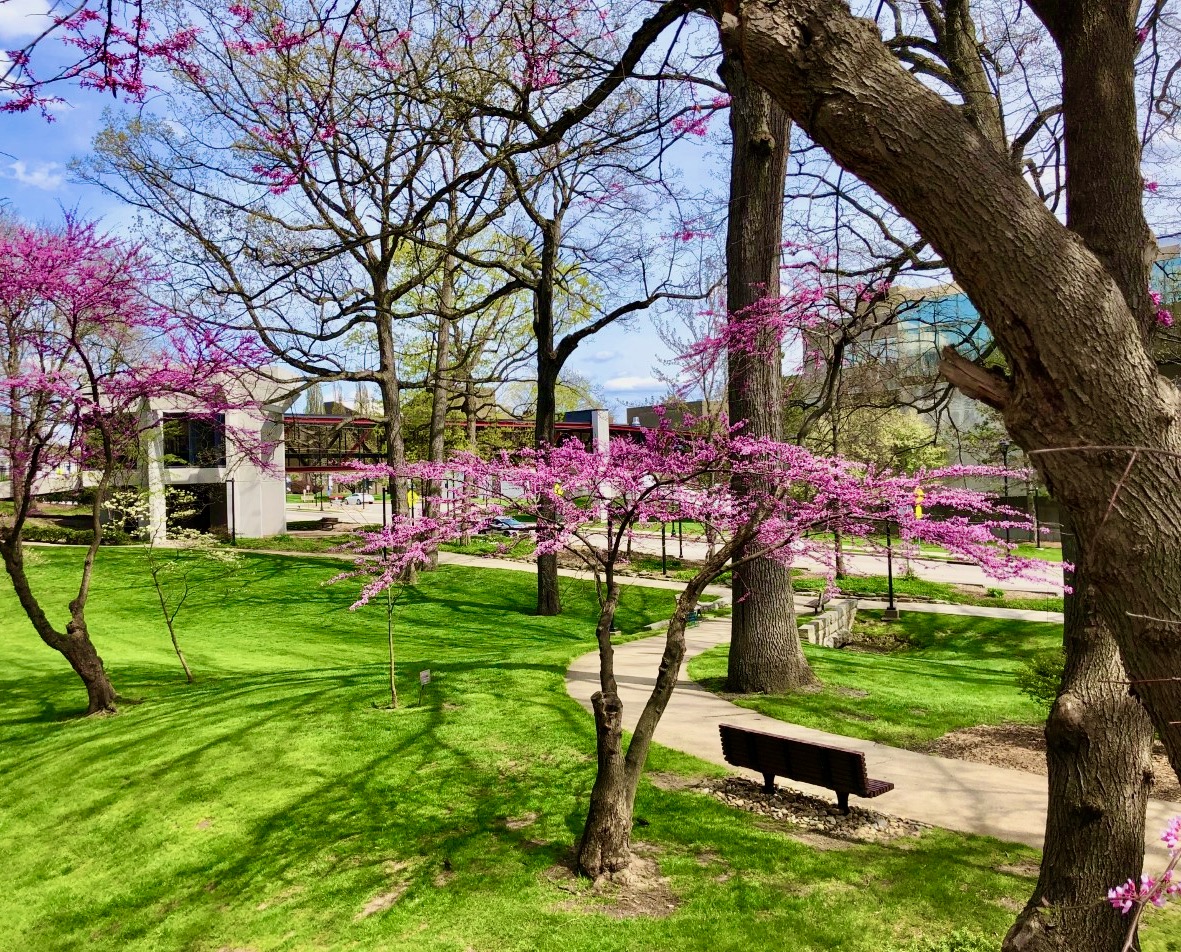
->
<box><xmin>328</xmin><ymin>411</ymin><xmax>1040</xmax><ymax>607</ymax></box>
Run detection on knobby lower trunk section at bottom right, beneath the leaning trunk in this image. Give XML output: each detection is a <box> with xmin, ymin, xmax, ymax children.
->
<box><xmin>1004</xmin><ymin>528</ymin><xmax>1153</xmax><ymax>952</ymax></box>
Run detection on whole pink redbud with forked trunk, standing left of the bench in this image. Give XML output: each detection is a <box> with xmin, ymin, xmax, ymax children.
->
<box><xmin>338</xmin><ymin>425</ymin><xmax>1033</xmax><ymax>878</ymax></box>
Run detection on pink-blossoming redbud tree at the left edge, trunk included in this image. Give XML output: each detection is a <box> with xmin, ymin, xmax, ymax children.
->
<box><xmin>0</xmin><ymin>220</ymin><xmax>266</xmax><ymax>715</ymax></box>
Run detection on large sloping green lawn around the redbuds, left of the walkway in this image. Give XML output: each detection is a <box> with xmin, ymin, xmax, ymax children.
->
<box><xmin>0</xmin><ymin>549</ymin><xmax>1170</xmax><ymax>952</ymax></box>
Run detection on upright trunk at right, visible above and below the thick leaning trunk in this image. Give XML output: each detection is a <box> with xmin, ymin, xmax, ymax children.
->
<box><xmin>1005</xmin><ymin>2</ymin><xmax>1155</xmax><ymax>952</ymax></box>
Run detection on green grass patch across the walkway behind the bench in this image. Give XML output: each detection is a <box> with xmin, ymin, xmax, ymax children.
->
<box><xmin>689</xmin><ymin>612</ymin><xmax>1062</xmax><ymax>749</ymax></box>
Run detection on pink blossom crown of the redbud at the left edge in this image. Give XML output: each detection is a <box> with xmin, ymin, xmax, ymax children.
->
<box><xmin>0</xmin><ymin>219</ymin><xmax>273</xmax><ymax>484</ymax></box>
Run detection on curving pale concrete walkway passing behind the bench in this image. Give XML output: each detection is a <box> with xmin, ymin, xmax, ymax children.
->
<box><xmin>566</xmin><ymin>606</ymin><xmax>1181</xmax><ymax>871</ymax></box>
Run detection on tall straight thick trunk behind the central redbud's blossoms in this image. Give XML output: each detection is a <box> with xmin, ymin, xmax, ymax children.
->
<box><xmin>719</xmin><ymin>46</ymin><xmax>814</xmax><ymax>693</ymax></box>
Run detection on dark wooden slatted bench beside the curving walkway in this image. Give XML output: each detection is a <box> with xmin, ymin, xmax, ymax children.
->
<box><xmin>719</xmin><ymin>724</ymin><xmax>894</xmax><ymax>813</ymax></box>
